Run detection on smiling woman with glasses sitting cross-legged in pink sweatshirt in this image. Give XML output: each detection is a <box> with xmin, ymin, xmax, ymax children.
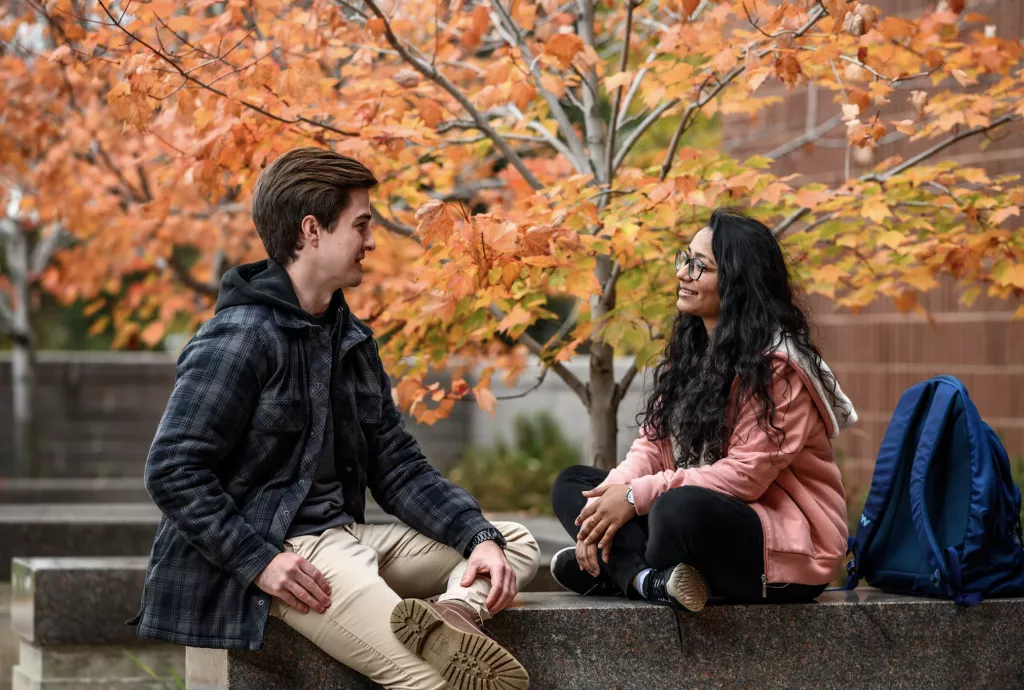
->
<box><xmin>551</xmin><ymin>209</ymin><xmax>856</xmax><ymax>611</ymax></box>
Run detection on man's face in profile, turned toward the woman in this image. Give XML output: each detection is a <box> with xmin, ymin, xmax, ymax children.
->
<box><xmin>316</xmin><ymin>189</ymin><xmax>377</xmax><ymax>290</ymax></box>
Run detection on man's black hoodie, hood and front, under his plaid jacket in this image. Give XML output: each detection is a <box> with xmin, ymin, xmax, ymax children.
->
<box><xmin>215</xmin><ymin>259</ymin><xmax>353</xmax><ymax>538</ymax></box>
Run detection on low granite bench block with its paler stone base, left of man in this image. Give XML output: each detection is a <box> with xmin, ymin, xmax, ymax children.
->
<box><xmin>5</xmin><ymin>557</ymin><xmax>184</xmax><ymax>690</ymax></box>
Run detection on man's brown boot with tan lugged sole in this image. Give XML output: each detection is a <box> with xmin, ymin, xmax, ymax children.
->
<box><xmin>391</xmin><ymin>599</ymin><xmax>529</xmax><ymax>690</ymax></box>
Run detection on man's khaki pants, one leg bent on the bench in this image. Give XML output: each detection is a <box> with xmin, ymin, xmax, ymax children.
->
<box><xmin>270</xmin><ymin>522</ymin><xmax>541</xmax><ymax>690</ymax></box>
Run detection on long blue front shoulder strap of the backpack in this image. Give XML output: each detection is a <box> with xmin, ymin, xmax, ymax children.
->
<box><xmin>910</xmin><ymin>377</ymin><xmax>981</xmax><ymax>606</ymax></box>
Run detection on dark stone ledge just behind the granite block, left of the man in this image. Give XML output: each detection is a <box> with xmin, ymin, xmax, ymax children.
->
<box><xmin>0</xmin><ymin>504</ymin><xmax>160</xmax><ymax>580</ymax></box>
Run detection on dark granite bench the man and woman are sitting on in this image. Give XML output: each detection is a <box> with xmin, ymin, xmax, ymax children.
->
<box><xmin>185</xmin><ymin>589</ymin><xmax>1024</xmax><ymax>690</ymax></box>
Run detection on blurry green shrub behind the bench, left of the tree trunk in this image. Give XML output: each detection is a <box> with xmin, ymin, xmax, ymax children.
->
<box><xmin>449</xmin><ymin>413</ymin><xmax>582</xmax><ymax>515</ymax></box>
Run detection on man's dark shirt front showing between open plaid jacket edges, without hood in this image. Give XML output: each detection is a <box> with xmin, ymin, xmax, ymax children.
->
<box><xmin>285</xmin><ymin>310</ymin><xmax>353</xmax><ymax>538</ymax></box>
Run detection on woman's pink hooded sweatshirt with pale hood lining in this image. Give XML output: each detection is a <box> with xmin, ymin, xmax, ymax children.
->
<box><xmin>601</xmin><ymin>341</ymin><xmax>857</xmax><ymax>585</ymax></box>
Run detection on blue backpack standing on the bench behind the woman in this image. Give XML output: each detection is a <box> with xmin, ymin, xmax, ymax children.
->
<box><xmin>844</xmin><ymin>376</ymin><xmax>1024</xmax><ymax>606</ymax></box>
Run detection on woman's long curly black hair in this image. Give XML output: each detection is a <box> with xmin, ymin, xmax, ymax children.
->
<box><xmin>638</xmin><ymin>209</ymin><xmax>836</xmax><ymax>467</ymax></box>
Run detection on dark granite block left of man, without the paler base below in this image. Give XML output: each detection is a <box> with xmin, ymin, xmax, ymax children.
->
<box><xmin>11</xmin><ymin>557</ymin><xmax>146</xmax><ymax>645</ymax></box>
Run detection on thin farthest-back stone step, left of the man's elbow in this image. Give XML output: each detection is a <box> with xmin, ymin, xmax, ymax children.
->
<box><xmin>0</xmin><ymin>477</ymin><xmax>153</xmax><ymax>505</ymax></box>
